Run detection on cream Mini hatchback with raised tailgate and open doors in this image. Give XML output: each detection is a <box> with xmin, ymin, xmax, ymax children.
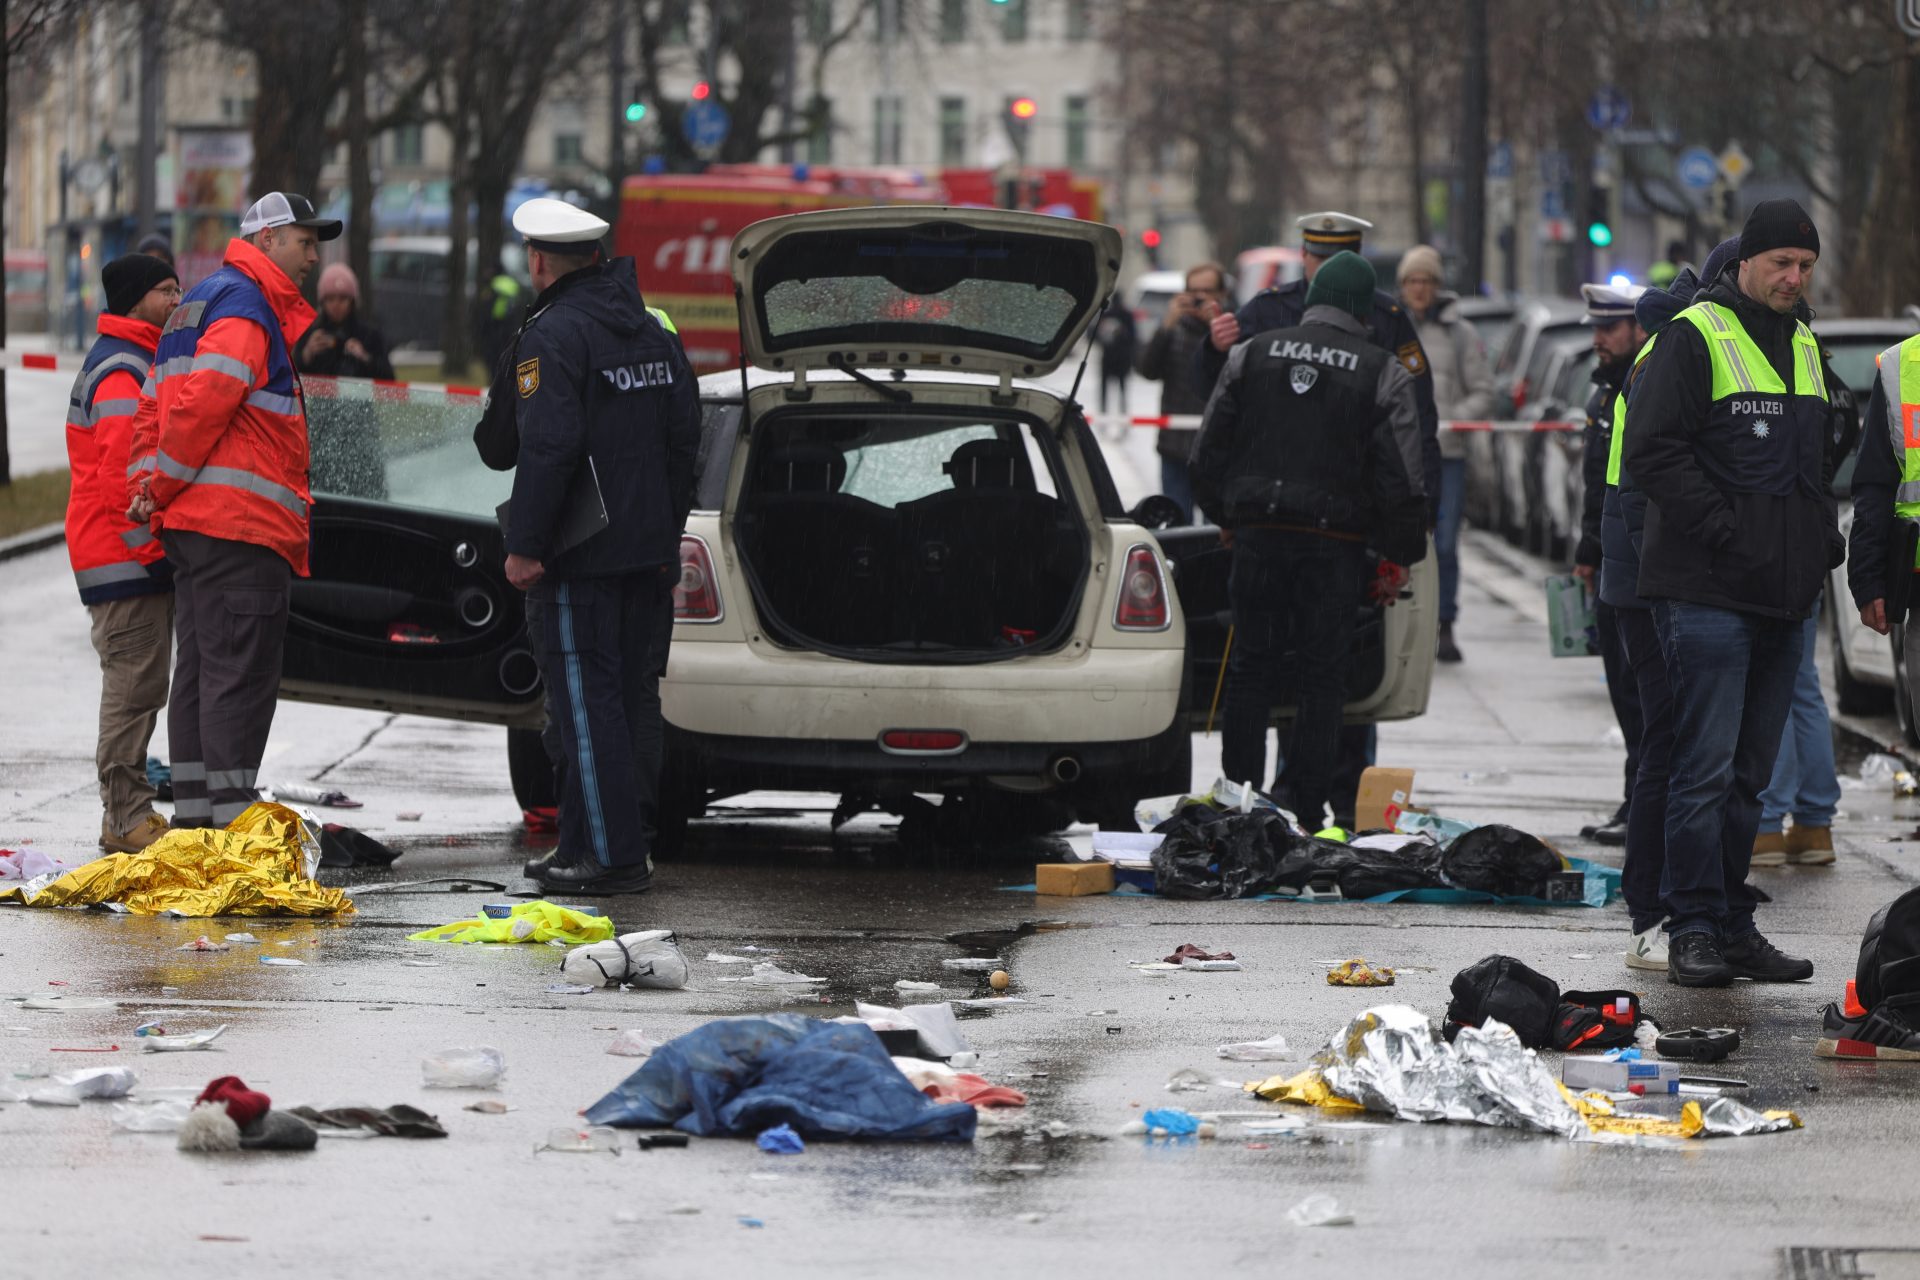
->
<box><xmin>282</xmin><ymin>207</ymin><xmax>1436</xmax><ymax>848</ymax></box>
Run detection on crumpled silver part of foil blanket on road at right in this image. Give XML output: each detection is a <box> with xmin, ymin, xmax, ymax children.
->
<box><xmin>1313</xmin><ymin>1004</ymin><xmax>1586</xmax><ymax>1138</ymax></box>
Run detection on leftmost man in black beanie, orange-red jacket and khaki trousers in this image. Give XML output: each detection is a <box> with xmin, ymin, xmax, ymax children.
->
<box><xmin>67</xmin><ymin>253</ymin><xmax>180</xmax><ymax>854</ymax></box>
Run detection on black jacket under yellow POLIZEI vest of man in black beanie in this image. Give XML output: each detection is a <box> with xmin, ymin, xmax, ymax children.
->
<box><xmin>1626</xmin><ymin>273</ymin><xmax>1845</xmax><ymax>618</ymax></box>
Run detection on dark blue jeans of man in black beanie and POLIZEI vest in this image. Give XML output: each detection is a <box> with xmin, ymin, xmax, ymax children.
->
<box><xmin>1653</xmin><ymin>601</ymin><xmax>1803</xmax><ymax>940</ymax></box>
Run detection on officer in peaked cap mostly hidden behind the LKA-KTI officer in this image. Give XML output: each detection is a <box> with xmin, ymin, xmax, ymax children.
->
<box><xmin>1194</xmin><ymin>211</ymin><xmax>1440</xmax><ymax>825</ymax></box>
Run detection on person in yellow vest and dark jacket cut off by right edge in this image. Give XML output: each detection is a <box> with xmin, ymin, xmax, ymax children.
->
<box><xmin>1847</xmin><ymin>334</ymin><xmax>1920</xmax><ymax>702</ymax></box>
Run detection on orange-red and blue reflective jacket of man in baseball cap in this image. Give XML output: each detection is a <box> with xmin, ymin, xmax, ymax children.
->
<box><xmin>127</xmin><ymin>240</ymin><xmax>313</xmax><ymax>576</ymax></box>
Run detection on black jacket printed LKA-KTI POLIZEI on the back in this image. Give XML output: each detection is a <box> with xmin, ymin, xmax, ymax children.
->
<box><xmin>1192</xmin><ymin>307</ymin><xmax>1427</xmax><ymax>564</ymax></box>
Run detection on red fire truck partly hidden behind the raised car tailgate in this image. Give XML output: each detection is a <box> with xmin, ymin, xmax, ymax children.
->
<box><xmin>614</xmin><ymin>165</ymin><xmax>1100</xmax><ymax>372</ymax></box>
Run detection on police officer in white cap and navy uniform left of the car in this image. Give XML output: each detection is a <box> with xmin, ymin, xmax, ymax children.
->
<box><xmin>505</xmin><ymin>200</ymin><xmax>701</xmax><ymax>894</ymax></box>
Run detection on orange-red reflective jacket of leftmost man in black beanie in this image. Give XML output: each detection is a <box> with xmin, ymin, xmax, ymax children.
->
<box><xmin>67</xmin><ymin>315</ymin><xmax>173</xmax><ymax>604</ymax></box>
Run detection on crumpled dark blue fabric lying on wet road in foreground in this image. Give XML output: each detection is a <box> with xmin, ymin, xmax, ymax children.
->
<box><xmin>586</xmin><ymin>1013</ymin><xmax>977</xmax><ymax>1142</ymax></box>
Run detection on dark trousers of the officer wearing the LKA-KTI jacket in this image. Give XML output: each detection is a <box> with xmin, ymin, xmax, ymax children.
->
<box><xmin>1221</xmin><ymin>530</ymin><xmax>1367</xmax><ymax>829</ymax></box>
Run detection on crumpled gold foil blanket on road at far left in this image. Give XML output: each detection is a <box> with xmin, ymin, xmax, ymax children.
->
<box><xmin>0</xmin><ymin>802</ymin><xmax>353</xmax><ymax>915</ymax></box>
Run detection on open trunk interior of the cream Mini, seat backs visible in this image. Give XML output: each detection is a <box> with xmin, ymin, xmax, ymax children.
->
<box><xmin>733</xmin><ymin>405</ymin><xmax>1091</xmax><ymax>662</ymax></box>
